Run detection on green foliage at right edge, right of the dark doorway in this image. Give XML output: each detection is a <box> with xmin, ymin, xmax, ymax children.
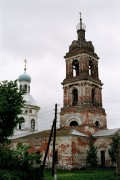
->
<box><xmin>109</xmin><ymin>134</ymin><xmax>120</xmax><ymax>163</ymax></box>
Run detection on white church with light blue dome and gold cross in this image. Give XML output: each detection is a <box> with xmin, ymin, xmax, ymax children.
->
<box><xmin>12</xmin><ymin>60</ymin><xmax>40</xmax><ymax>138</ymax></box>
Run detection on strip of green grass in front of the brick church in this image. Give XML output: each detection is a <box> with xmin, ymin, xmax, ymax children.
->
<box><xmin>44</xmin><ymin>168</ymin><xmax>120</xmax><ymax>180</ymax></box>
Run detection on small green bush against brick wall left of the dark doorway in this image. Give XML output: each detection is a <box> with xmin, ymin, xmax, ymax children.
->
<box><xmin>86</xmin><ymin>139</ymin><xmax>98</xmax><ymax>167</ymax></box>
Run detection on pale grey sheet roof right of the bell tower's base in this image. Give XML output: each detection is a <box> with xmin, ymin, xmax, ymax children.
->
<box><xmin>93</xmin><ymin>128</ymin><xmax>120</xmax><ymax>137</ymax></box>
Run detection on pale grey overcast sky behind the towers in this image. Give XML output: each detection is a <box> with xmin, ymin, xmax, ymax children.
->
<box><xmin>0</xmin><ymin>0</ymin><xmax>120</xmax><ymax>130</ymax></box>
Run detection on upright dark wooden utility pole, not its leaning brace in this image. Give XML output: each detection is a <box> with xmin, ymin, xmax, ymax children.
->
<box><xmin>52</xmin><ymin>104</ymin><xmax>57</xmax><ymax>180</ymax></box>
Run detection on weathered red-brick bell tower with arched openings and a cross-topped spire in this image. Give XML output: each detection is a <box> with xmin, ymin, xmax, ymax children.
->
<box><xmin>60</xmin><ymin>13</ymin><xmax>107</xmax><ymax>134</ymax></box>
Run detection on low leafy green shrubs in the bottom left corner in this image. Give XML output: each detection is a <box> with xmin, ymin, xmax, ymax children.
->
<box><xmin>0</xmin><ymin>143</ymin><xmax>40</xmax><ymax>180</ymax></box>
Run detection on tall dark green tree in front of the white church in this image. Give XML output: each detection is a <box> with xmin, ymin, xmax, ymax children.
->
<box><xmin>0</xmin><ymin>80</ymin><xmax>24</xmax><ymax>143</ymax></box>
